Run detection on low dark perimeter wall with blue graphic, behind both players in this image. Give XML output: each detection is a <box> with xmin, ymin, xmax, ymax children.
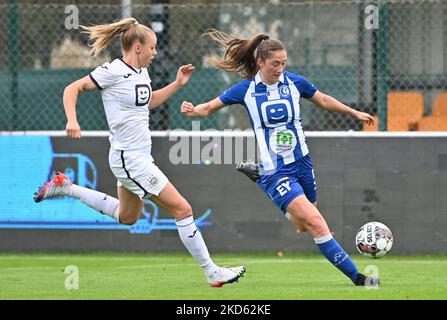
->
<box><xmin>0</xmin><ymin>132</ymin><xmax>447</xmax><ymax>254</ymax></box>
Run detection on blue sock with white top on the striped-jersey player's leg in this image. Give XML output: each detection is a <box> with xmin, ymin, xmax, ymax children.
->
<box><xmin>314</xmin><ymin>234</ymin><xmax>360</xmax><ymax>283</ymax></box>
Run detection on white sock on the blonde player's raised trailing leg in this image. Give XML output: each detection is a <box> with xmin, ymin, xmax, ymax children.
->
<box><xmin>70</xmin><ymin>184</ymin><xmax>120</xmax><ymax>222</ymax></box>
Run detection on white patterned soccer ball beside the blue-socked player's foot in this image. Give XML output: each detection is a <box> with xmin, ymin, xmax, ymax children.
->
<box><xmin>355</xmin><ymin>222</ymin><xmax>393</xmax><ymax>258</ymax></box>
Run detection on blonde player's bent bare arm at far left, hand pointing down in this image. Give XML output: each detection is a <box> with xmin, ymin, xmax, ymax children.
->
<box><xmin>63</xmin><ymin>76</ymin><xmax>97</xmax><ymax>138</ymax></box>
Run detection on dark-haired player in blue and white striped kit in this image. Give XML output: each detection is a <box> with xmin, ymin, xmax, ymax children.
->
<box><xmin>181</xmin><ymin>30</ymin><xmax>378</xmax><ymax>285</ymax></box>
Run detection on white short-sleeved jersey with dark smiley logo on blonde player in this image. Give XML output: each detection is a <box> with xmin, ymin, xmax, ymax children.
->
<box><xmin>90</xmin><ymin>58</ymin><xmax>152</xmax><ymax>150</ymax></box>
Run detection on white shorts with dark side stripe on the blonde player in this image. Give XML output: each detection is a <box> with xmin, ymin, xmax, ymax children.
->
<box><xmin>109</xmin><ymin>148</ymin><xmax>169</xmax><ymax>199</ymax></box>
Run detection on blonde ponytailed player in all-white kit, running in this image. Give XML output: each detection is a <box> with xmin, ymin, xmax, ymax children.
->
<box><xmin>34</xmin><ymin>18</ymin><xmax>245</xmax><ymax>287</ymax></box>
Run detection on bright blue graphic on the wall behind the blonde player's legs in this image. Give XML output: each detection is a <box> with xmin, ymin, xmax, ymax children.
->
<box><xmin>0</xmin><ymin>135</ymin><xmax>212</xmax><ymax>234</ymax></box>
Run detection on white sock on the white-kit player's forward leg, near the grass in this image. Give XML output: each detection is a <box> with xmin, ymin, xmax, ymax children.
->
<box><xmin>175</xmin><ymin>216</ymin><xmax>218</xmax><ymax>277</ymax></box>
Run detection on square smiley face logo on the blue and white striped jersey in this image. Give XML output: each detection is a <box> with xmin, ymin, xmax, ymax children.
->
<box><xmin>261</xmin><ymin>99</ymin><xmax>292</xmax><ymax>127</ymax></box>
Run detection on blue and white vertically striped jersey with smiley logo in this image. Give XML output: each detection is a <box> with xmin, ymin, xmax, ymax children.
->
<box><xmin>219</xmin><ymin>71</ymin><xmax>317</xmax><ymax>171</ymax></box>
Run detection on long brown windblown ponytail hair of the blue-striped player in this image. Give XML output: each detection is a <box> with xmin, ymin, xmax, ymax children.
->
<box><xmin>203</xmin><ymin>29</ymin><xmax>285</xmax><ymax>79</ymax></box>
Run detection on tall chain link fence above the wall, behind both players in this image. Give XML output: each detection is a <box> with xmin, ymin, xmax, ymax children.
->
<box><xmin>0</xmin><ymin>0</ymin><xmax>447</xmax><ymax>131</ymax></box>
